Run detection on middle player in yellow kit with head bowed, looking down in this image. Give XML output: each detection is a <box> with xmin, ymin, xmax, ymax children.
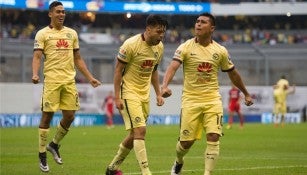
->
<box><xmin>106</xmin><ymin>15</ymin><xmax>167</xmax><ymax>175</ymax></box>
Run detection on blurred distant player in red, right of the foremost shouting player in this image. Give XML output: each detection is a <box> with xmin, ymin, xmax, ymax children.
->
<box><xmin>227</xmin><ymin>84</ymin><xmax>244</xmax><ymax>129</ymax></box>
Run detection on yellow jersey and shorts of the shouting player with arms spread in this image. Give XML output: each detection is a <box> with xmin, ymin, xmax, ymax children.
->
<box><xmin>173</xmin><ymin>38</ymin><xmax>234</xmax><ymax>141</ymax></box>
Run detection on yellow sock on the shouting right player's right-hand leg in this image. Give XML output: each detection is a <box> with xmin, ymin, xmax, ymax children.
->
<box><xmin>204</xmin><ymin>141</ymin><xmax>220</xmax><ymax>175</ymax></box>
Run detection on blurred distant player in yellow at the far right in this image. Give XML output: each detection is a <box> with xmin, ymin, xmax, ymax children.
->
<box><xmin>273</xmin><ymin>75</ymin><xmax>295</xmax><ymax>127</ymax></box>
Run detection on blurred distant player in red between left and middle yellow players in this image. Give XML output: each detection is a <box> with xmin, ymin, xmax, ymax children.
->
<box><xmin>101</xmin><ymin>91</ymin><xmax>114</xmax><ymax>129</ymax></box>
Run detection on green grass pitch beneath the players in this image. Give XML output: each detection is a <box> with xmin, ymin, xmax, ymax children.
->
<box><xmin>0</xmin><ymin>123</ymin><xmax>307</xmax><ymax>175</ymax></box>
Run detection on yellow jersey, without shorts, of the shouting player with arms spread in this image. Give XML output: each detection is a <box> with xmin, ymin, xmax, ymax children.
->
<box><xmin>173</xmin><ymin>38</ymin><xmax>234</xmax><ymax>107</ymax></box>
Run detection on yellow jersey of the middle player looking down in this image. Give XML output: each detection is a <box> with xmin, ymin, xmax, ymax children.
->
<box><xmin>117</xmin><ymin>34</ymin><xmax>164</xmax><ymax>102</ymax></box>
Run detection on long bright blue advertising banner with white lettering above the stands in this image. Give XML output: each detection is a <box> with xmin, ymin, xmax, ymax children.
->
<box><xmin>0</xmin><ymin>0</ymin><xmax>211</xmax><ymax>15</ymax></box>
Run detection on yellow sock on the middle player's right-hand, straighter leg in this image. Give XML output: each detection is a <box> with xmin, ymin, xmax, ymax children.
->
<box><xmin>133</xmin><ymin>140</ymin><xmax>151</xmax><ymax>175</ymax></box>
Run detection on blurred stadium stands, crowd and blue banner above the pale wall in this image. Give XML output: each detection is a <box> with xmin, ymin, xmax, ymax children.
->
<box><xmin>0</xmin><ymin>0</ymin><xmax>307</xmax><ymax>86</ymax></box>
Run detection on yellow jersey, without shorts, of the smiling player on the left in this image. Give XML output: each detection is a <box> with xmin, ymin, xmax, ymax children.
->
<box><xmin>34</xmin><ymin>26</ymin><xmax>79</xmax><ymax>83</ymax></box>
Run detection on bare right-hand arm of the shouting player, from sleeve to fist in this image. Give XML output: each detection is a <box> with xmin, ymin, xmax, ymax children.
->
<box><xmin>228</xmin><ymin>69</ymin><xmax>253</xmax><ymax>106</ymax></box>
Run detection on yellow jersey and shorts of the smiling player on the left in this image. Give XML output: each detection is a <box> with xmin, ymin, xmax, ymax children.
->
<box><xmin>34</xmin><ymin>26</ymin><xmax>80</xmax><ymax>112</ymax></box>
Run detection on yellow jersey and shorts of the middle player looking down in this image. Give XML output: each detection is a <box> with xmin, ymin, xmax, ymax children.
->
<box><xmin>117</xmin><ymin>34</ymin><xmax>164</xmax><ymax>129</ymax></box>
